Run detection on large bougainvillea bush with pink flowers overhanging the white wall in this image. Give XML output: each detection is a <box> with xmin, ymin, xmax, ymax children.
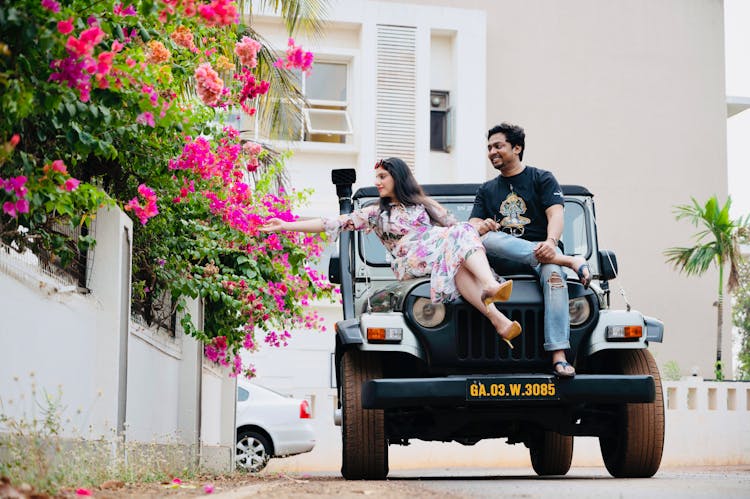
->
<box><xmin>0</xmin><ymin>0</ymin><xmax>332</xmax><ymax>374</ymax></box>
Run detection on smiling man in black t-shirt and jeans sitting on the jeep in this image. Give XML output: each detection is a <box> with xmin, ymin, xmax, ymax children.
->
<box><xmin>469</xmin><ymin>123</ymin><xmax>591</xmax><ymax>377</ymax></box>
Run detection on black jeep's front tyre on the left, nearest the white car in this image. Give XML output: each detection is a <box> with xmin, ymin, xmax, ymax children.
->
<box><xmin>341</xmin><ymin>350</ymin><xmax>388</xmax><ymax>480</ymax></box>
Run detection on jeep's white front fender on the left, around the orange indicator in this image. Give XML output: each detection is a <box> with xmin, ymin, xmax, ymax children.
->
<box><xmin>336</xmin><ymin>312</ymin><xmax>427</xmax><ymax>361</ymax></box>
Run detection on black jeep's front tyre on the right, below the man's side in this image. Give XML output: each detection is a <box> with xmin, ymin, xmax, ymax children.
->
<box><xmin>599</xmin><ymin>350</ymin><xmax>664</xmax><ymax>478</ymax></box>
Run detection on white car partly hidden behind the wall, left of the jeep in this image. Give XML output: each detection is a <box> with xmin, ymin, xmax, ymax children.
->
<box><xmin>235</xmin><ymin>381</ymin><xmax>315</xmax><ymax>473</ymax></box>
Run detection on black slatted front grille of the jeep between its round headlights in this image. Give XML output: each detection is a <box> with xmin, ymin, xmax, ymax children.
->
<box><xmin>454</xmin><ymin>305</ymin><xmax>547</xmax><ymax>364</ymax></box>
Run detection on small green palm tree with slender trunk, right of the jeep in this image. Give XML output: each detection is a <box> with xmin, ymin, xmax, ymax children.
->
<box><xmin>664</xmin><ymin>196</ymin><xmax>750</xmax><ymax>380</ymax></box>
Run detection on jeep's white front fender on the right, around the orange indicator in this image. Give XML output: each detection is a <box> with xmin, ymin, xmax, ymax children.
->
<box><xmin>581</xmin><ymin>310</ymin><xmax>664</xmax><ymax>356</ymax></box>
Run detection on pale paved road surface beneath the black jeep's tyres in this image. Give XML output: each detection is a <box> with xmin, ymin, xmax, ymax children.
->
<box><xmin>214</xmin><ymin>466</ymin><xmax>750</xmax><ymax>499</ymax></box>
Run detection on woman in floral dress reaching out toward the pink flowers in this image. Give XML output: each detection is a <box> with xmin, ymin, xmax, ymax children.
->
<box><xmin>261</xmin><ymin>158</ymin><xmax>521</xmax><ymax>348</ymax></box>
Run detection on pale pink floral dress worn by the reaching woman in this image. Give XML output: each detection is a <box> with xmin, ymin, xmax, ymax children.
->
<box><xmin>323</xmin><ymin>204</ymin><xmax>484</xmax><ymax>303</ymax></box>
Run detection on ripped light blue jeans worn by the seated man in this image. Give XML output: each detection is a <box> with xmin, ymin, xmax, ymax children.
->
<box><xmin>482</xmin><ymin>232</ymin><xmax>570</xmax><ymax>352</ymax></box>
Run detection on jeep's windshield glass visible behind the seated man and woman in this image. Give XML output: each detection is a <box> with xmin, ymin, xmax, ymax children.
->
<box><xmin>359</xmin><ymin>199</ymin><xmax>591</xmax><ymax>267</ymax></box>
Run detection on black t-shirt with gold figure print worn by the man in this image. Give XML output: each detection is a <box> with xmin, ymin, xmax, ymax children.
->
<box><xmin>471</xmin><ymin>166</ymin><xmax>565</xmax><ymax>241</ymax></box>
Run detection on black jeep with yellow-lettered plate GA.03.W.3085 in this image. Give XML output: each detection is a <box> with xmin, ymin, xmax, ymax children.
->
<box><xmin>330</xmin><ymin>170</ymin><xmax>664</xmax><ymax>479</ymax></box>
